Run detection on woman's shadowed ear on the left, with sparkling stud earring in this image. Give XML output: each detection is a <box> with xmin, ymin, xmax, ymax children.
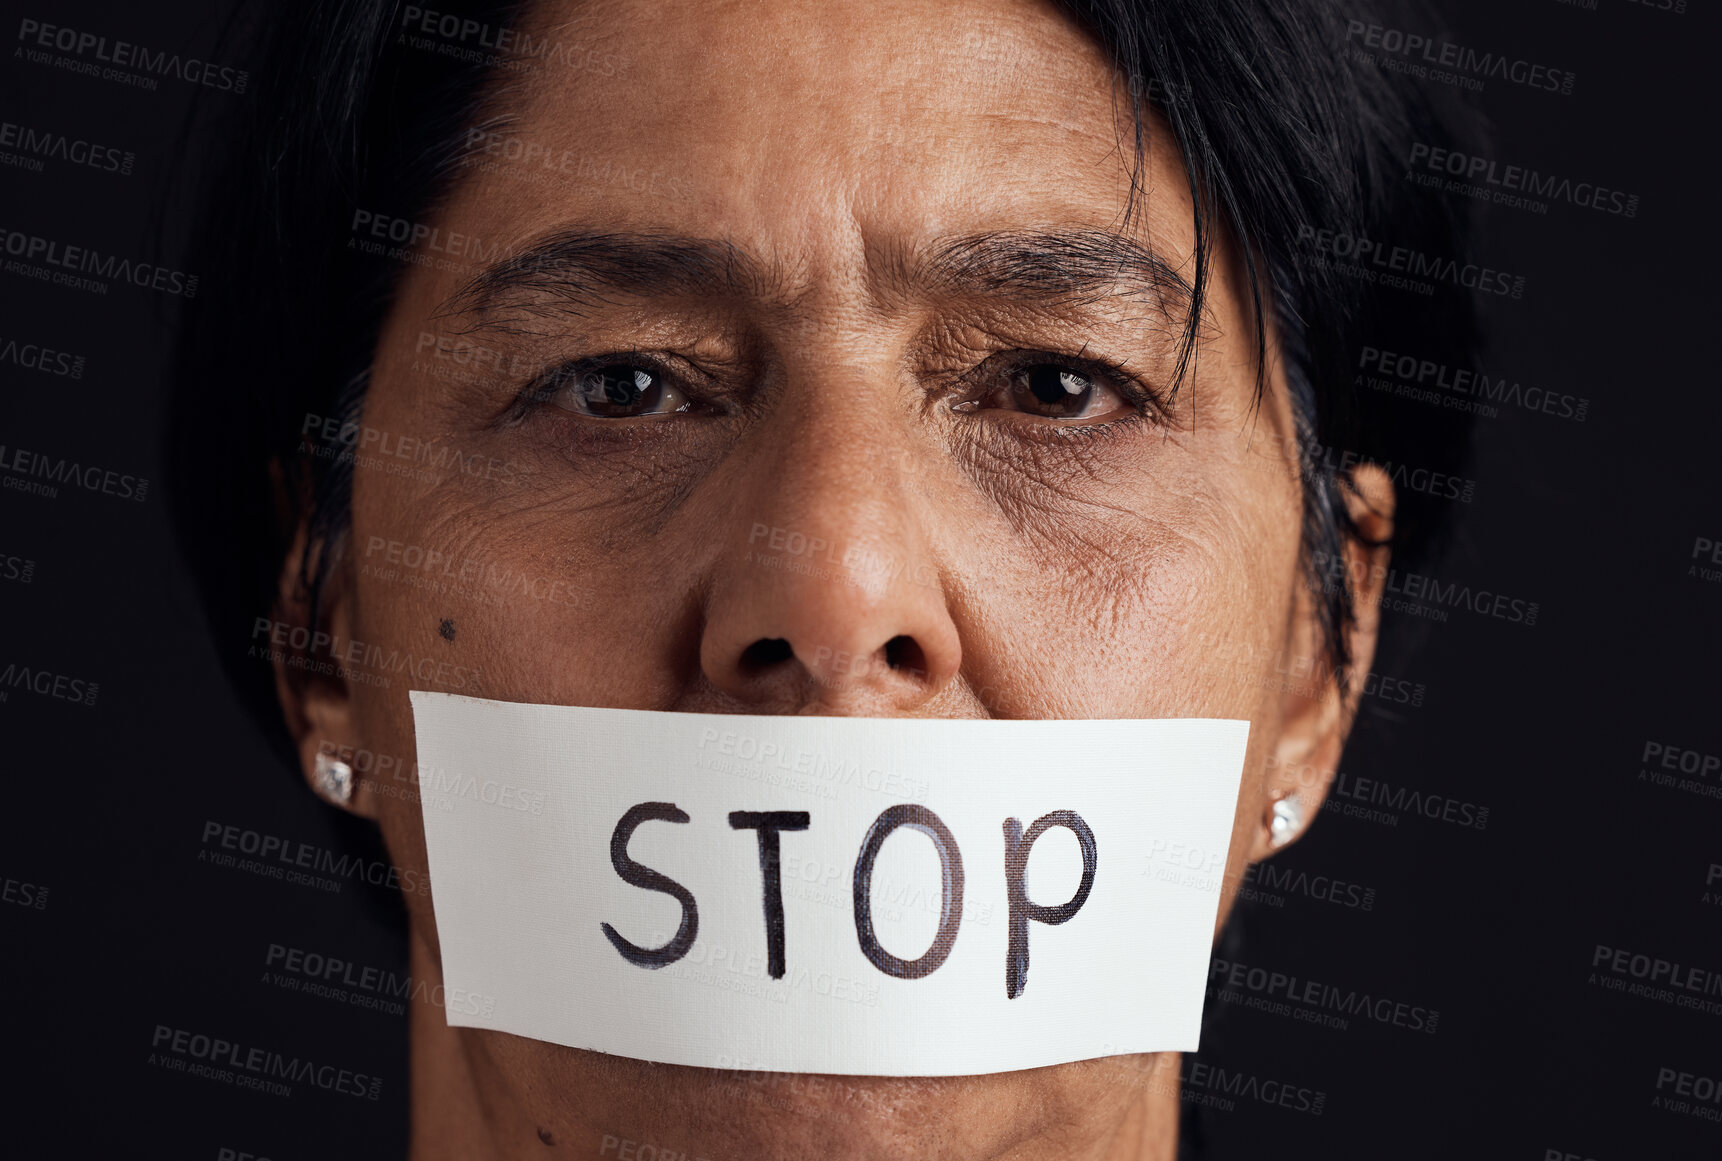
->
<box><xmin>274</xmin><ymin>522</ymin><xmax>377</xmax><ymax>818</ymax></box>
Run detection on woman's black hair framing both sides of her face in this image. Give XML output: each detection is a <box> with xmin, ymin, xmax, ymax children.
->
<box><xmin>167</xmin><ymin>0</ymin><xmax>1476</xmax><ymax>749</ymax></box>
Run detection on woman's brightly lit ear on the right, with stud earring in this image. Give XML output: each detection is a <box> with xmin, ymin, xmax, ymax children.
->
<box><xmin>1250</xmin><ymin>463</ymin><xmax>1393</xmax><ymax>863</ymax></box>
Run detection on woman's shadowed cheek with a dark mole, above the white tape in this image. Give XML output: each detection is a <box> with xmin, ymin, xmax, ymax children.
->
<box><xmin>351</xmin><ymin>444</ymin><xmax>697</xmax><ymax>713</ymax></box>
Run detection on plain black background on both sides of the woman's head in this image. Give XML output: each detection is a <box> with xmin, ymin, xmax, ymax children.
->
<box><xmin>0</xmin><ymin>0</ymin><xmax>1722</xmax><ymax>1161</ymax></box>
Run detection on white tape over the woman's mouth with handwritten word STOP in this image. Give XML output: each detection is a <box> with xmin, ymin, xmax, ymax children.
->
<box><xmin>412</xmin><ymin>691</ymin><xmax>1248</xmax><ymax>1077</ymax></box>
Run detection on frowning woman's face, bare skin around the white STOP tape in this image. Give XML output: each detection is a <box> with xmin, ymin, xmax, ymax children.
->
<box><xmin>289</xmin><ymin>0</ymin><xmax>1369</xmax><ymax>1158</ymax></box>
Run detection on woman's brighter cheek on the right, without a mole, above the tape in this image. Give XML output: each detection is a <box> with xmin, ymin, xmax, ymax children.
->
<box><xmin>964</xmin><ymin>444</ymin><xmax>1298</xmax><ymax>722</ymax></box>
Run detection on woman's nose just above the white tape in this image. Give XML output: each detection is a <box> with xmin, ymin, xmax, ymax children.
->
<box><xmin>699</xmin><ymin>411</ymin><xmax>963</xmax><ymax>717</ymax></box>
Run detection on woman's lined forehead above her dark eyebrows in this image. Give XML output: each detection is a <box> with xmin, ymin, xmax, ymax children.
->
<box><xmin>437</xmin><ymin>0</ymin><xmax>1181</xmax><ymax>262</ymax></box>
